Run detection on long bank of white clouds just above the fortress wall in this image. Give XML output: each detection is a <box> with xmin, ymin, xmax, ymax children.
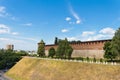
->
<box><xmin>65</xmin><ymin>28</ymin><xmax>115</xmax><ymax>41</ymax></box>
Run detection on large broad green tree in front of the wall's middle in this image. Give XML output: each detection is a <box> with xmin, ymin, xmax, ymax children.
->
<box><xmin>56</xmin><ymin>38</ymin><xmax>73</xmax><ymax>58</ymax></box>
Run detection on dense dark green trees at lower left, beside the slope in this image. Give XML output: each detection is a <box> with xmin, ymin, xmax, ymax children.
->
<box><xmin>0</xmin><ymin>49</ymin><xmax>21</xmax><ymax>69</ymax></box>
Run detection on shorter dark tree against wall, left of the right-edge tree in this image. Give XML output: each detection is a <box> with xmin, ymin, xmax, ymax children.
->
<box><xmin>103</xmin><ymin>41</ymin><xmax>115</xmax><ymax>61</ymax></box>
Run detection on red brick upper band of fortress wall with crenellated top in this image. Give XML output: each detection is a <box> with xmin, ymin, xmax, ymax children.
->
<box><xmin>42</xmin><ymin>39</ymin><xmax>111</xmax><ymax>50</ymax></box>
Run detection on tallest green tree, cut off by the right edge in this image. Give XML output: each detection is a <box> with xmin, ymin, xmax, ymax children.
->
<box><xmin>111</xmin><ymin>28</ymin><xmax>120</xmax><ymax>59</ymax></box>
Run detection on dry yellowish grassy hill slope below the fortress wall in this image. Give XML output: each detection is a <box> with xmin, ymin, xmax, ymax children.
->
<box><xmin>6</xmin><ymin>57</ymin><xmax>120</xmax><ymax>80</ymax></box>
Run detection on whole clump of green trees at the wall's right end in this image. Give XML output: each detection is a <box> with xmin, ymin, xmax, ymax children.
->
<box><xmin>103</xmin><ymin>28</ymin><xmax>120</xmax><ymax>61</ymax></box>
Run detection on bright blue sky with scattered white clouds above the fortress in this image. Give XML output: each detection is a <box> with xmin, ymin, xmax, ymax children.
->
<box><xmin>0</xmin><ymin>0</ymin><xmax>120</xmax><ymax>50</ymax></box>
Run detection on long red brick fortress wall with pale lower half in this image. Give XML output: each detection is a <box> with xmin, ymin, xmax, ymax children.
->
<box><xmin>45</xmin><ymin>40</ymin><xmax>111</xmax><ymax>58</ymax></box>
